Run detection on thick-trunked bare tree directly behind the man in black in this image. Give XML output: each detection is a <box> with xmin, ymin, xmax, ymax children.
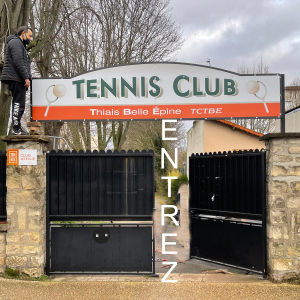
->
<box><xmin>0</xmin><ymin>0</ymin><xmax>62</xmax><ymax>148</ymax></box>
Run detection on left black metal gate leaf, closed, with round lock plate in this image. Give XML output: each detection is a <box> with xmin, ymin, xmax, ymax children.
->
<box><xmin>46</xmin><ymin>150</ymin><xmax>155</xmax><ymax>275</ymax></box>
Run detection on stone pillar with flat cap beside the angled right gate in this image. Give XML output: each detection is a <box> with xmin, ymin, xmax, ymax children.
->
<box><xmin>261</xmin><ymin>133</ymin><xmax>300</xmax><ymax>281</ymax></box>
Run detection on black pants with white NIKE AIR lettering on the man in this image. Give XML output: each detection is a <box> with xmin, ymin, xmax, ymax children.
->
<box><xmin>8</xmin><ymin>81</ymin><xmax>26</xmax><ymax>130</ymax></box>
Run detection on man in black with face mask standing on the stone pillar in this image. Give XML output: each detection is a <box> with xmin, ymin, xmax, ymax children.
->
<box><xmin>1</xmin><ymin>26</ymin><xmax>32</xmax><ymax>135</ymax></box>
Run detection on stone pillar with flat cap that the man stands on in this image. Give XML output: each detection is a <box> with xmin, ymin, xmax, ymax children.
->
<box><xmin>0</xmin><ymin>136</ymin><xmax>50</xmax><ymax>277</ymax></box>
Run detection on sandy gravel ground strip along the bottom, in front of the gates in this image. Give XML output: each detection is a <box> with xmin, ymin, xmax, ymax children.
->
<box><xmin>0</xmin><ymin>280</ymin><xmax>300</xmax><ymax>300</ymax></box>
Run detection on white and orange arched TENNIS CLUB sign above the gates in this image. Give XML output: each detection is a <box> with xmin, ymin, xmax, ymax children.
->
<box><xmin>32</xmin><ymin>63</ymin><xmax>281</xmax><ymax>121</ymax></box>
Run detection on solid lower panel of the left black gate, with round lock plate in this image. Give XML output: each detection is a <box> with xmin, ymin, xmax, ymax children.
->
<box><xmin>50</xmin><ymin>224</ymin><xmax>152</xmax><ymax>273</ymax></box>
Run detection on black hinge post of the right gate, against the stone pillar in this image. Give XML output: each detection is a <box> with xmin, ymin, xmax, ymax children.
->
<box><xmin>261</xmin><ymin>152</ymin><xmax>267</xmax><ymax>275</ymax></box>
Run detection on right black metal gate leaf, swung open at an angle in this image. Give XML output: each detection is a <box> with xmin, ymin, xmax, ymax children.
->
<box><xmin>189</xmin><ymin>150</ymin><xmax>266</xmax><ymax>273</ymax></box>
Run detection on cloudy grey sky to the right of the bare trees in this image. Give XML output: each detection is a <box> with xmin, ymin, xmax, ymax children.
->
<box><xmin>171</xmin><ymin>0</ymin><xmax>300</xmax><ymax>85</ymax></box>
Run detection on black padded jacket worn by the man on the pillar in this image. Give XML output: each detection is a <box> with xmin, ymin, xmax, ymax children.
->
<box><xmin>1</xmin><ymin>34</ymin><xmax>31</xmax><ymax>84</ymax></box>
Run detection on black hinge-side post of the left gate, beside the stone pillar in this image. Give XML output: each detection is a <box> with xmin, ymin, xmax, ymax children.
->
<box><xmin>46</xmin><ymin>153</ymin><xmax>51</xmax><ymax>275</ymax></box>
